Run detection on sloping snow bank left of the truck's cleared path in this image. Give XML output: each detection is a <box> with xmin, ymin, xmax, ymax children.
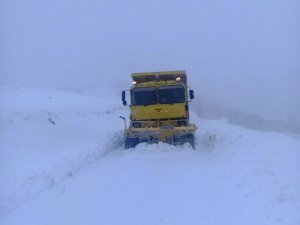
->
<box><xmin>0</xmin><ymin>87</ymin><xmax>123</xmax><ymax>215</ymax></box>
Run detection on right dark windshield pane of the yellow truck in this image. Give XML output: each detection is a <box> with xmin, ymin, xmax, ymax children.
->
<box><xmin>158</xmin><ymin>85</ymin><xmax>185</xmax><ymax>104</ymax></box>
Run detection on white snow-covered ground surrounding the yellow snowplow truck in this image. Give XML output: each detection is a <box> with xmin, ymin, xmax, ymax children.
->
<box><xmin>0</xmin><ymin>87</ymin><xmax>300</xmax><ymax>225</ymax></box>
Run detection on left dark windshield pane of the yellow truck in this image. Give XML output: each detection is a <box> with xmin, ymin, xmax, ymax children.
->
<box><xmin>131</xmin><ymin>87</ymin><xmax>158</xmax><ymax>105</ymax></box>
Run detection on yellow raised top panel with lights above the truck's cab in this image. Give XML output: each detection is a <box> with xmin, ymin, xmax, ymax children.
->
<box><xmin>131</xmin><ymin>70</ymin><xmax>186</xmax><ymax>83</ymax></box>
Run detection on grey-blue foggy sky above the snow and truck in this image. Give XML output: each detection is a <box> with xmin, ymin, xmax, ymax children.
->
<box><xmin>0</xmin><ymin>0</ymin><xmax>300</xmax><ymax>118</ymax></box>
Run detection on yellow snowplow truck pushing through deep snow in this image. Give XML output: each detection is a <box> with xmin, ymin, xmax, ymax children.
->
<box><xmin>121</xmin><ymin>71</ymin><xmax>197</xmax><ymax>149</ymax></box>
